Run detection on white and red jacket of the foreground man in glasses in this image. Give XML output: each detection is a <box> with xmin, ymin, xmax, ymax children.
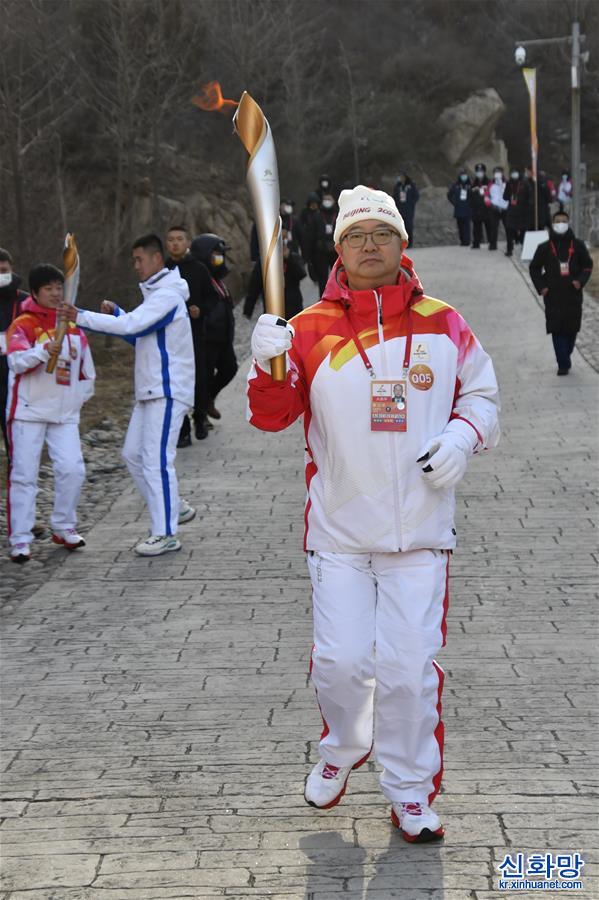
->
<box><xmin>248</xmin><ymin>255</ymin><xmax>499</xmax><ymax>553</ymax></box>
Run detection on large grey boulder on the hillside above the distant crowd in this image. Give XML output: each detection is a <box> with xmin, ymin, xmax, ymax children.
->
<box><xmin>437</xmin><ymin>88</ymin><xmax>507</xmax><ymax>168</ymax></box>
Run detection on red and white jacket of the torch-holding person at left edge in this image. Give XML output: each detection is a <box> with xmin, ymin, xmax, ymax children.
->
<box><xmin>6</xmin><ymin>297</ymin><xmax>96</xmax><ymax>424</ymax></box>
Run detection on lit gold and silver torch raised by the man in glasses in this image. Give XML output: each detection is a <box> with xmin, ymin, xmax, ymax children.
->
<box><xmin>233</xmin><ymin>91</ymin><xmax>286</xmax><ymax>381</ymax></box>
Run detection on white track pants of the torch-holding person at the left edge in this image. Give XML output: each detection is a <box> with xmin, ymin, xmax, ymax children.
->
<box><xmin>7</xmin><ymin>419</ymin><xmax>85</xmax><ymax>547</ymax></box>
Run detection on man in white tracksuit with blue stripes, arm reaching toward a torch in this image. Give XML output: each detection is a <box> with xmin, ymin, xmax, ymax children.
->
<box><xmin>69</xmin><ymin>234</ymin><xmax>195</xmax><ymax>556</ymax></box>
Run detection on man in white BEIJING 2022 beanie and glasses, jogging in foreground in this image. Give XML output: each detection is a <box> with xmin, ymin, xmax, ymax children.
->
<box><xmin>248</xmin><ymin>185</ymin><xmax>499</xmax><ymax>841</ymax></box>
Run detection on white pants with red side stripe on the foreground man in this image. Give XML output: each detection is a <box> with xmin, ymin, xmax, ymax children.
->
<box><xmin>307</xmin><ymin>550</ymin><xmax>449</xmax><ymax>803</ymax></box>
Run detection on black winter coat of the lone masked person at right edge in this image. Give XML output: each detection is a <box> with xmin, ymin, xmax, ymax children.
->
<box><xmin>529</xmin><ymin>229</ymin><xmax>593</xmax><ymax>334</ymax></box>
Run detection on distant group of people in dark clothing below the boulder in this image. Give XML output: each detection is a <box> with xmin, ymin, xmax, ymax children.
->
<box><xmin>447</xmin><ymin>163</ymin><xmax>572</xmax><ymax>256</ymax></box>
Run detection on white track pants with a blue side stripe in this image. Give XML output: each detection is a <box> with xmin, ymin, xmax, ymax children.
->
<box><xmin>123</xmin><ymin>397</ymin><xmax>187</xmax><ymax>535</ymax></box>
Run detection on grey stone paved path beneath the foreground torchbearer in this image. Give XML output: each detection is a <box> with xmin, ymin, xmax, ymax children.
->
<box><xmin>0</xmin><ymin>247</ymin><xmax>599</xmax><ymax>900</ymax></box>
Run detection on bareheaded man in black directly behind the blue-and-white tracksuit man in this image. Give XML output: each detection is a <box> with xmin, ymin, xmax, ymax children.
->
<box><xmin>165</xmin><ymin>225</ymin><xmax>213</xmax><ymax>447</ymax></box>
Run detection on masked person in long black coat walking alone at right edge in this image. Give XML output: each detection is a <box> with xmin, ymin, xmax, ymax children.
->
<box><xmin>529</xmin><ymin>211</ymin><xmax>593</xmax><ymax>375</ymax></box>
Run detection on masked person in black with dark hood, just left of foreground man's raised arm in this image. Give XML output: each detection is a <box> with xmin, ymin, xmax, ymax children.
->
<box><xmin>191</xmin><ymin>234</ymin><xmax>238</xmax><ymax>419</ymax></box>
